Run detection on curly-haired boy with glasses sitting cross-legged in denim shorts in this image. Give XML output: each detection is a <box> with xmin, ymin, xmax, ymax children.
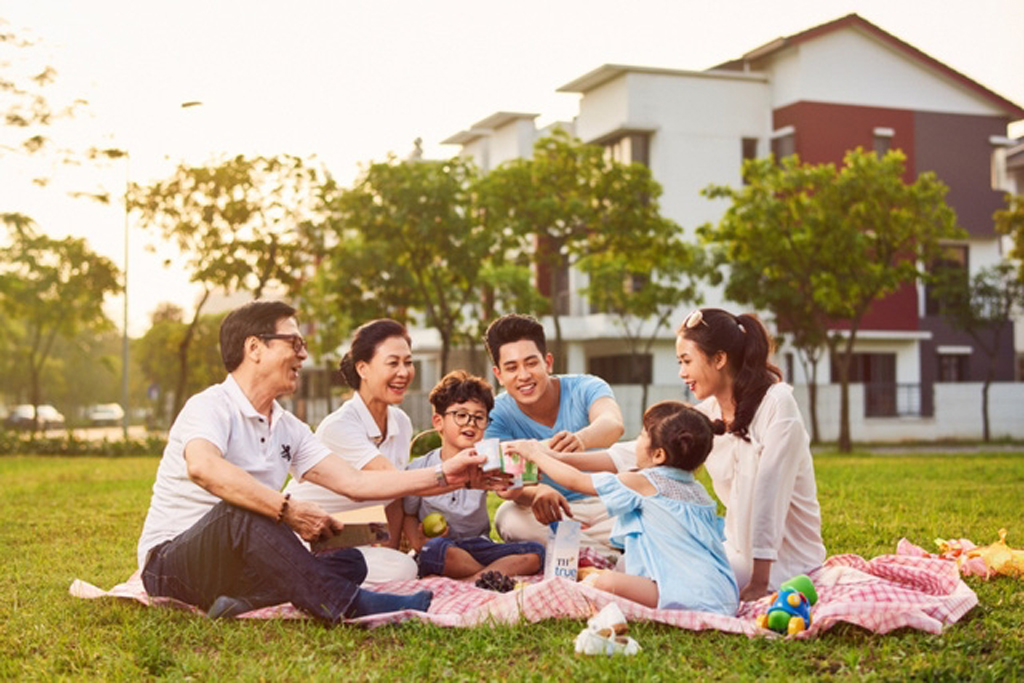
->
<box><xmin>403</xmin><ymin>370</ymin><xmax>544</xmax><ymax>581</ymax></box>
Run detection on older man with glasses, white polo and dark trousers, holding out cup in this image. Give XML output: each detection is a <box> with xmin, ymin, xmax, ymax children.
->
<box><xmin>138</xmin><ymin>301</ymin><xmax>484</xmax><ymax>623</ymax></box>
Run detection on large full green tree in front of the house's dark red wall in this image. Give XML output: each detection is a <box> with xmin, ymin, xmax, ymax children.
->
<box><xmin>703</xmin><ymin>148</ymin><xmax>964</xmax><ymax>453</ymax></box>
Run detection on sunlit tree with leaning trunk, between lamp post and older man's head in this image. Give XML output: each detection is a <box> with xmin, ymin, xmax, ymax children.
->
<box><xmin>129</xmin><ymin>156</ymin><xmax>319</xmax><ymax>415</ymax></box>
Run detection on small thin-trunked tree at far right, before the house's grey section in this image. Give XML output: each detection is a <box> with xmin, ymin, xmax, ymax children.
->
<box><xmin>935</xmin><ymin>261</ymin><xmax>1024</xmax><ymax>442</ymax></box>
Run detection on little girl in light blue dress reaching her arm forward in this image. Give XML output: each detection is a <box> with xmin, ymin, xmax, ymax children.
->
<box><xmin>506</xmin><ymin>400</ymin><xmax>739</xmax><ymax>615</ymax></box>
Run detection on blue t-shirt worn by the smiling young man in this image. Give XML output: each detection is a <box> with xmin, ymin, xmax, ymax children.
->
<box><xmin>486</xmin><ymin>375</ymin><xmax>615</xmax><ymax>501</ymax></box>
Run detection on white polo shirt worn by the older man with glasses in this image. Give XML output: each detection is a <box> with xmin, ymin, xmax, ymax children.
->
<box><xmin>138</xmin><ymin>375</ymin><xmax>331</xmax><ymax>568</ymax></box>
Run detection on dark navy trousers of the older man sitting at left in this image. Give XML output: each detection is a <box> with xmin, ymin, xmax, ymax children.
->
<box><xmin>142</xmin><ymin>502</ymin><xmax>367</xmax><ymax>623</ymax></box>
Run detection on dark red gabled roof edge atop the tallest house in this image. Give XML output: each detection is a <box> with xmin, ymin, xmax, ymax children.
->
<box><xmin>729</xmin><ymin>14</ymin><xmax>1024</xmax><ymax>119</ymax></box>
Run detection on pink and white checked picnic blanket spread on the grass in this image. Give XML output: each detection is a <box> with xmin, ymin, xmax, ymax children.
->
<box><xmin>70</xmin><ymin>539</ymin><xmax>978</xmax><ymax>639</ymax></box>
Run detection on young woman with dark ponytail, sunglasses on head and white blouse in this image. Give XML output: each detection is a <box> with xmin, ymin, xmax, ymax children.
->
<box><xmin>676</xmin><ymin>308</ymin><xmax>825</xmax><ymax>600</ymax></box>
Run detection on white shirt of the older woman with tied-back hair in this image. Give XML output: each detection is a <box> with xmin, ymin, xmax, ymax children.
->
<box><xmin>285</xmin><ymin>391</ymin><xmax>413</xmax><ymax>514</ymax></box>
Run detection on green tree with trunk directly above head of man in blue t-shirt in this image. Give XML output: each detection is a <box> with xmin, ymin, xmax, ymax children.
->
<box><xmin>480</xmin><ymin>129</ymin><xmax>670</xmax><ymax>366</ymax></box>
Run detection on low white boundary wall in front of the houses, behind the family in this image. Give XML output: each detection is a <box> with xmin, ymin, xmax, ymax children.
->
<box><xmin>305</xmin><ymin>382</ymin><xmax>1024</xmax><ymax>442</ymax></box>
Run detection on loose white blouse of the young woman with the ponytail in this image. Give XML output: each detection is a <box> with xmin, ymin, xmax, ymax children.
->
<box><xmin>695</xmin><ymin>382</ymin><xmax>825</xmax><ymax>589</ymax></box>
